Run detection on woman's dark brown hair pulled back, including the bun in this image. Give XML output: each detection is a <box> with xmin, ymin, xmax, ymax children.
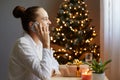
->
<box><xmin>13</xmin><ymin>6</ymin><xmax>40</xmax><ymax>32</ymax></box>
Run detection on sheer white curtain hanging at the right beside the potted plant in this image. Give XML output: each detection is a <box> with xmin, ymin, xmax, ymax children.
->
<box><xmin>100</xmin><ymin>0</ymin><xmax>120</xmax><ymax>80</ymax></box>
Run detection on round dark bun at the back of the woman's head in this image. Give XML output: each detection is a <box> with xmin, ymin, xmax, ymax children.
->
<box><xmin>13</xmin><ymin>6</ymin><xmax>25</xmax><ymax>18</ymax></box>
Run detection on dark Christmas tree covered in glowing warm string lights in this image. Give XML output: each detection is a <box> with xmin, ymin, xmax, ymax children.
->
<box><xmin>51</xmin><ymin>0</ymin><xmax>100</xmax><ymax>64</ymax></box>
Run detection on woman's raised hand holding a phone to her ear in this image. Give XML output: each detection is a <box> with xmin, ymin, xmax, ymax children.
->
<box><xmin>31</xmin><ymin>22</ymin><xmax>50</xmax><ymax>48</ymax></box>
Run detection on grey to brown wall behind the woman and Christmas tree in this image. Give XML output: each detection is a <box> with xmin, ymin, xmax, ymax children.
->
<box><xmin>0</xmin><ymin>0</ymin><xmax>99</xmax><ymax>80</ymax></box>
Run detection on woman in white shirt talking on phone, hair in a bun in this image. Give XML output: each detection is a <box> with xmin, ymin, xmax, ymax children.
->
<box><xmin>9</xmin><ymin>6</ymin><xmax>59</xmax><ymax>80</ymax></box>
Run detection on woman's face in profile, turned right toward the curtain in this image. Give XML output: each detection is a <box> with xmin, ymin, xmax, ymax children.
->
<box><xmin>36</xmin><ymin>8</ymin><xmax>51</xmax><ymax>27</ymax></box>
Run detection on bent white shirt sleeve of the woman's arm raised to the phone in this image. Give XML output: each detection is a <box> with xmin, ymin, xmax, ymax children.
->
<box><xmin>18</xmin><ymin>42</ymin><xmax>53</xmax><ymax>80</ymax></box>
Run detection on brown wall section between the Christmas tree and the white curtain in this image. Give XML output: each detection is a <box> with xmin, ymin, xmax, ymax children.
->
<box><xmin>87</xmin><ymin>0</ymin><xmax>100</xmax><ymax>44</ymax></box>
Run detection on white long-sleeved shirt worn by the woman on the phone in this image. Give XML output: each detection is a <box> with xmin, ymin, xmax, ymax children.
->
<box><xmin>9</xmin><ymin>33</ymin><xmax>59</xmax><ymax>80</ymax></box>
